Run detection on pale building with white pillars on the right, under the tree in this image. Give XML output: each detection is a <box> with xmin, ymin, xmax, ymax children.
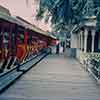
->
<box><xmin>71</xmin><ymin>16</ymin><xmax>100</xmax><ymax>63</ymax></box>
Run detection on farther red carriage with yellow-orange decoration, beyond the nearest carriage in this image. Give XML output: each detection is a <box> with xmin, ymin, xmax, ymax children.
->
<box><xmin>16</xmin><ymin>16</ymin><xmax>55</xmax><ymax>60</ymax></box>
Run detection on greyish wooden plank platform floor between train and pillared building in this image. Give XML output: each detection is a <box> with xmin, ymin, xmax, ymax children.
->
<box><xmin>0</xmin><ymin>55</ymin><xmax>100</xmax><ymax>100</ymax></box>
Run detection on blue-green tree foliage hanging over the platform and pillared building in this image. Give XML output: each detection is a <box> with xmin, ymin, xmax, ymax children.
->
<box><xmin>36</xmin><ymin>0</ymin><xmax>100</xmax><ymax>30</ymax></box>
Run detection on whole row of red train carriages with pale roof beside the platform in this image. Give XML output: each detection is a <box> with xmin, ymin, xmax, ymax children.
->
<box><xmin>0</xmin><ymin>15</ymin><xmax>55</xmax><ymax>72</ymax></box>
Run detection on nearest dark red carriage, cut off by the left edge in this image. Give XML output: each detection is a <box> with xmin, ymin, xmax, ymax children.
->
<box><xmin>0</xmin><ymin>16</ymin><xmax>16</xmax><ymax>72</ymax></box>
